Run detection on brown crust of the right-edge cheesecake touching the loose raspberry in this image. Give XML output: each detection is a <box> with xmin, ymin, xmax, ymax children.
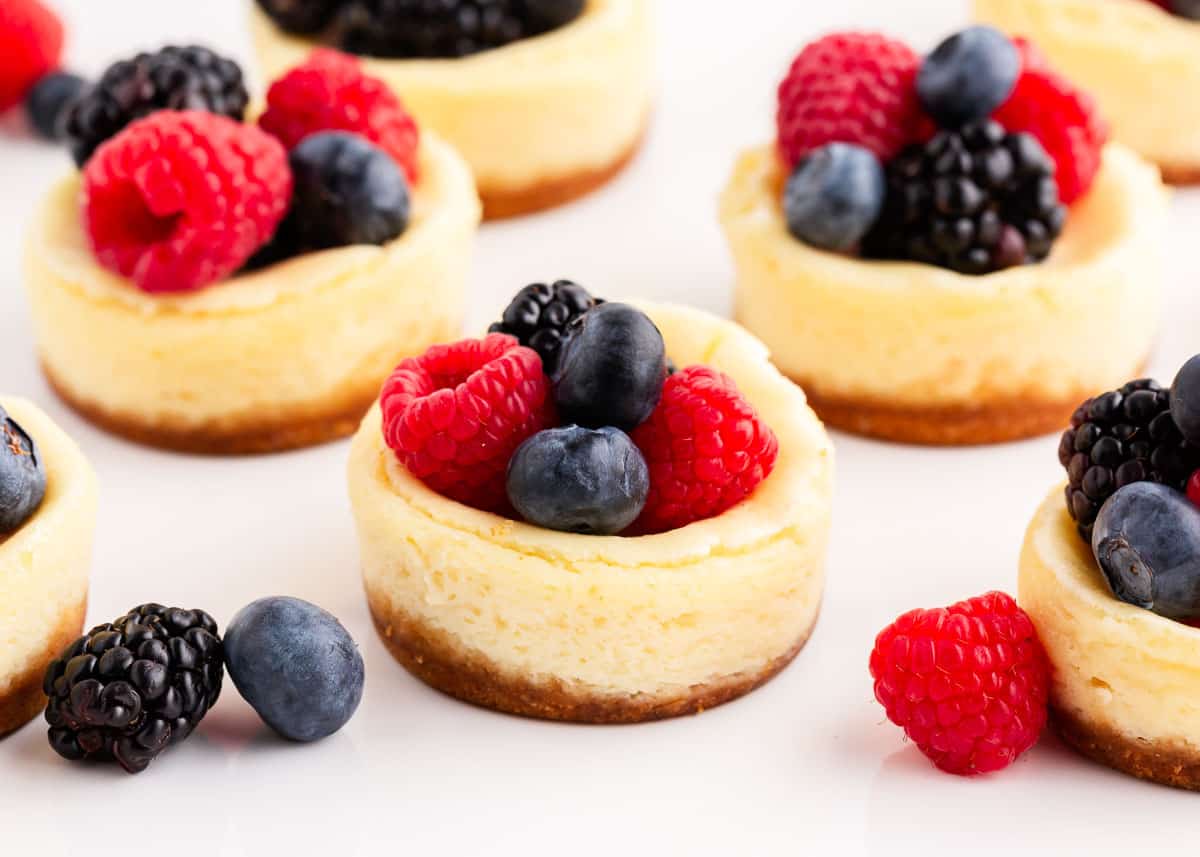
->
<box><xmin>1050</xmin><ymin>706</ymin><xmax>1200</xmax><ymax>791</ymax></box>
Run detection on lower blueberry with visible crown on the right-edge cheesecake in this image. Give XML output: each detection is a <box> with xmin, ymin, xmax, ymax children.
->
<box><xmin>1092</xmin><ymin>483</ymin><xmax>1200</xmax><ymax>619</ymax></box>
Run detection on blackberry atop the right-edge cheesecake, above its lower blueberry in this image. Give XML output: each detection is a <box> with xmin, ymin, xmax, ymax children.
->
<box><xmin>1058</xmin><ymin>379</ymin><xmax>1200</xmax><ymax>541</ymax></box>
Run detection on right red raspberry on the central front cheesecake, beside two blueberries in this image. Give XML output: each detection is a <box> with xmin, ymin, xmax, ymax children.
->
<box><xmin>632</xmin><ymin>366</ymin><xmax>779</xmax><ymax>533</ymax></box>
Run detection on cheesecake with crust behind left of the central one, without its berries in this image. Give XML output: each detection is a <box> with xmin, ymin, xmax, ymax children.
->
<box><xmin>25</xmin><ymin>133</ymin><xmax>480</xmax><ymax>454</ymax></box>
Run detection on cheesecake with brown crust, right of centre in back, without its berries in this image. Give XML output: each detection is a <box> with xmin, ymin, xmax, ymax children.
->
<box><xmin>720</xmin><ymin>145</ymin><xmax>1168</xmax><ymax>444</ymax></box>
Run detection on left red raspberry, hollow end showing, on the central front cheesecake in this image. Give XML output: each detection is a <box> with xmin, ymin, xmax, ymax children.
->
<box><xmin>379</xmin><ymin>334</ymin><xmax>554</xmax><ymax>514</ymax></box>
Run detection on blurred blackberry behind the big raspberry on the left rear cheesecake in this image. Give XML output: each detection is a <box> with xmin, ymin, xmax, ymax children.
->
<box><xmin>64</xmin><ymin>46</ymin><xmax>250</xmax><ymax>167</ymax></box>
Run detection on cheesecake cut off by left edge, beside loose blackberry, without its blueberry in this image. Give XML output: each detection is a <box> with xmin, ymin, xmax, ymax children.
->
<box><xmin>0</xmin><ymin>397</ymin><xmax>96</xmax><ymax>736</ymax></box>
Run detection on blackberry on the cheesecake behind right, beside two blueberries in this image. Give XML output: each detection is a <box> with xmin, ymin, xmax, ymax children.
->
<box><xmin>863</xmin><ymin>120</ymin><xmax>1067</xmax><ymax>274</ymax></box>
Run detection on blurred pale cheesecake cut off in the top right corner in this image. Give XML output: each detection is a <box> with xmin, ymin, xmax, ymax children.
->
<box><xmin>974</xmin><ymin>0</ymin><xmax>1200</xmax><ymax>184</ymax></box>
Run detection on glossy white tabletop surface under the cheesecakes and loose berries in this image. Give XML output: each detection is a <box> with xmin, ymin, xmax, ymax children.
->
<box><xmin>0</xmin><ymin>0</ymin><xmax>1200</xmax><ymax>857</ymax></box>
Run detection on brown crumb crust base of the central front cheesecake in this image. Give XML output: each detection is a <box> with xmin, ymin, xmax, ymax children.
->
<box><xmin>367</xmin><ymin>591</ymin><xmax>816</xmax><ymax>724</ymax></box>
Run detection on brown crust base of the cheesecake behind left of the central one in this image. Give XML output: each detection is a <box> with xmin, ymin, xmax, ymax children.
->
<box><xmin>42</xmin><ymin>360</ymin><xmax>379</xmax><ymax>455</ymax></box>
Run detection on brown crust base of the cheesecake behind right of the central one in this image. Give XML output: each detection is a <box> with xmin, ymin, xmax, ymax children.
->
<box><xmin>792</xmin><ymin>377</ymin><xmax>1092</xmax><ymax>447</ymax></box>
